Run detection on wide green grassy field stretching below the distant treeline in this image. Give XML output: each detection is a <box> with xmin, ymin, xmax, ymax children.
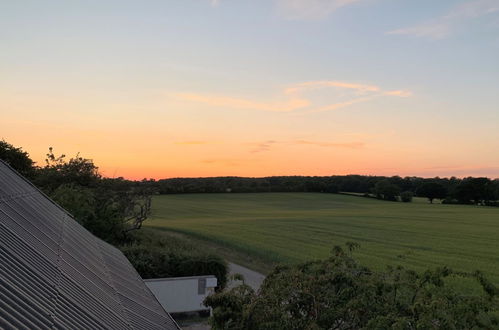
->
<box><xmin>146</xmin><ymin>193</ymin><xmax>499</xmax><ymax>284</ymax></box>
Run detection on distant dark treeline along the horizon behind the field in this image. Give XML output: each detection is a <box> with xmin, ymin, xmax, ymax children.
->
<box><xmin>147</xmin><ymin>175</ymin><xmax>499</xmax><ymax>206</ymax></box>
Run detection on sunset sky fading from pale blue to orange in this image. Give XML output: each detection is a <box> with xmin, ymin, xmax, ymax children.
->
<box><xmin>0</xmin><ymin>0</ymin><xmax>499</xmax><ymax>179</ymax></box>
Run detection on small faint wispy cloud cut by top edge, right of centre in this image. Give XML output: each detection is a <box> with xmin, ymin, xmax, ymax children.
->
<box><xmin>277</xmin><ymin>0</ymin><xmax>362</xmax><ymax>20</ymax></box>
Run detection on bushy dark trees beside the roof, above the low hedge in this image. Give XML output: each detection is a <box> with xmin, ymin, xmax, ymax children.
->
<box><xmin>34</xmin><ymin>148</ymin><xmax>151</xmax><ymax>244</ymax></box>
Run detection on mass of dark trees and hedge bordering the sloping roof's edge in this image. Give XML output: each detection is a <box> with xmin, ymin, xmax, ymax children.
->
<box><xmin>0</xmin><ymin>141</ymin><xmax>227</xmax><ymax>288</ymax></box>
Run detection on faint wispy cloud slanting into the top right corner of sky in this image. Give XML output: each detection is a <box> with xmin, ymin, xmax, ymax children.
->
<box><xmin>387</xmin><ymin>0</ymin><xmax>499</xmax><ymax>40</ymax></box>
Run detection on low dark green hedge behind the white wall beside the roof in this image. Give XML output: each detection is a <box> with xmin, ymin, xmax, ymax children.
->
<box><xmin>120</xmin><ymin>232</ymin><xmax>228</xmax><ymax>288</ymax></box>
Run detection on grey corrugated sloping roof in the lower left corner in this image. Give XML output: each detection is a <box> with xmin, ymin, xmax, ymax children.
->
<box><xmin>0</xmin><ymin>161</ymin><xmax>178</xmax><ymax>329</ymax></box>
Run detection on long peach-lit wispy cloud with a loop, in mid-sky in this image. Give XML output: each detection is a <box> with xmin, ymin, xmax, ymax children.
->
<box><xmin>173</xmin><ymin>80</ymin><xmax>412</xmax><ymax>114</ymax></box>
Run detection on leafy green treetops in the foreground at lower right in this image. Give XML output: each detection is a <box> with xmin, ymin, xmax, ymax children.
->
<box><xmin>206</xmin><ymin>247</ymin><xmax>499</xmax><ymax>330</ymax></box>
